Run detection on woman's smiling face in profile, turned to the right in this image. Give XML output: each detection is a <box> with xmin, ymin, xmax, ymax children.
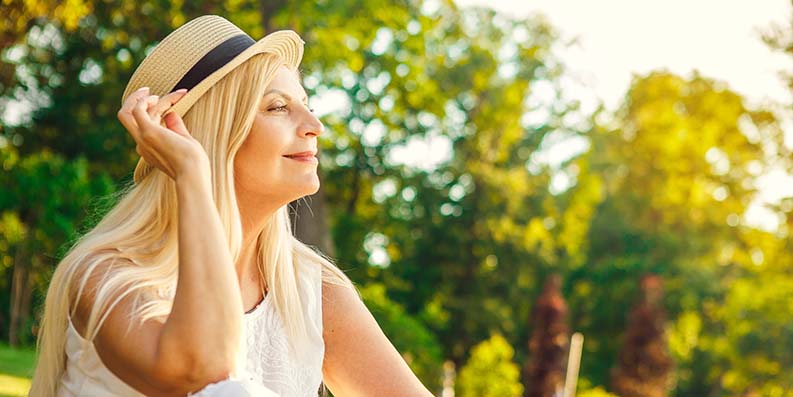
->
<box><xmin>234</xmin><ymin>66</ymin><xmax>325</xmax><ymax>204</ymax></box>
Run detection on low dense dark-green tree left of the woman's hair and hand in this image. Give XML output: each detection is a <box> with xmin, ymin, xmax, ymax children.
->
<box><xmin>0</xmin><ymin>147</ymin><xmax>114</xmax><ymax>346</ymax></box>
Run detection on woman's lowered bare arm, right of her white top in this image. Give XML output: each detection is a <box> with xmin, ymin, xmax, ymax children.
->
<box><xmin>322</xmin><ymin>283</ymin><xmax>432</xmax><ymax>397</ymax></box>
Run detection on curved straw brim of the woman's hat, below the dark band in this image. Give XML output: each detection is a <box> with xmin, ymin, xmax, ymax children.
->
<box><xmin>133</xmin><ymin>30</ymin><xmax>304</xmax><ymax>183</ymax></box>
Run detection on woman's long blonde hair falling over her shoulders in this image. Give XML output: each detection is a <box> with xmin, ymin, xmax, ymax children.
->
<box><xmin>30</xmin><ymin>54</ymin><xmax>355</xmax><ymax>397</ymax></box>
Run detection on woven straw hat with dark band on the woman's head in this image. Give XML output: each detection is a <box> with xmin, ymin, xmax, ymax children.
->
<box><xmin>121</xmin><ymin>15</ymin><xmax>304</xmax><ymax>183</ymax></box>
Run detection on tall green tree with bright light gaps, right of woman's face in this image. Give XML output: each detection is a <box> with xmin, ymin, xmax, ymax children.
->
<box><xmin>318</xmin><ymin>5</ymin><xmax>586</xmax><ymax>367</ymax></box>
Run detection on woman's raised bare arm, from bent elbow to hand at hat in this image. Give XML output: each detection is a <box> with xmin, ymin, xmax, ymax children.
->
<box><xmin>70</xmin><ymin>88</ymin><xmax>242</xmax><ymax>396</ymax></box>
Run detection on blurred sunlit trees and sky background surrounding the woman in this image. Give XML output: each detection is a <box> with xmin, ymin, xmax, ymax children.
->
<box><xmin>0</xmin><ymin>0</ymin><xmax>793</xmax><ymax>397</ymax></box>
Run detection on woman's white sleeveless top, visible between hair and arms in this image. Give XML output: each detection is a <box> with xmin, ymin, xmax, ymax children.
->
<box><xmin>57</xmin><ymin>262</ymin><xmax>325</xmax><ymax>397</ymax></box>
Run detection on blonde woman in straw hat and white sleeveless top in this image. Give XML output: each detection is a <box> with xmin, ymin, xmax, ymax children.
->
<box><xmin>30</xmin><ymin>16</ymin><xmax>431</xmax><ymax>397</ymax></box>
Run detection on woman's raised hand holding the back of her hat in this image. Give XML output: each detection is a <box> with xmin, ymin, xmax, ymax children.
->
<box><xmin>118</xmin><ymin>87</ymin><xmax>210</xmax><ymax>180</ymax></box>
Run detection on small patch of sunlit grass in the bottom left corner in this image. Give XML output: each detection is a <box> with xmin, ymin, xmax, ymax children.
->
<box><xmin>0</xmin><ymin>343</ymin><xmax>36</xmax><ymax>397</ymax></box>
